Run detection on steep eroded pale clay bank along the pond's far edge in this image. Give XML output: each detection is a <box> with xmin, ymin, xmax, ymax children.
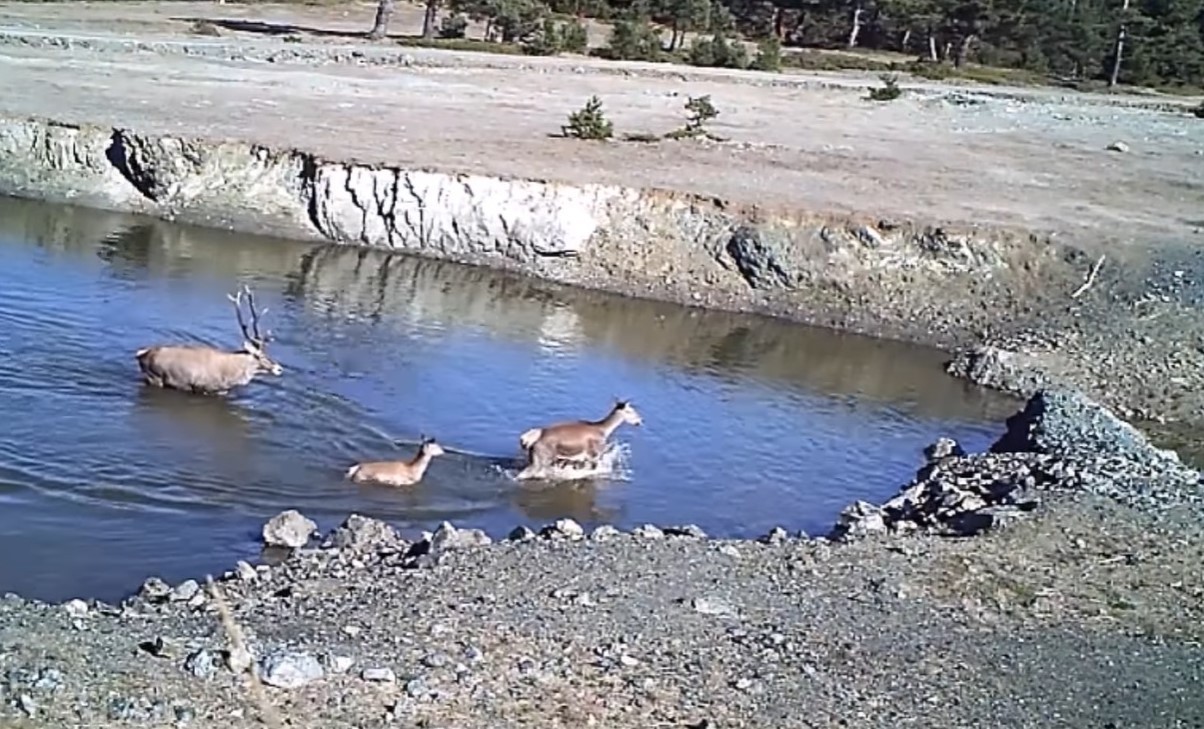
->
<box><xmin>0</xmin><ymin>112</ymin><xmax>1204</xmax><ymax>421</ymax></box>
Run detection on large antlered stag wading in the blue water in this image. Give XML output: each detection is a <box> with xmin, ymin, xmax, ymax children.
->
<box><xmin>135</xmin><ymin>286</ymin><xmax>284</xmax><ymax>395</ymax></box>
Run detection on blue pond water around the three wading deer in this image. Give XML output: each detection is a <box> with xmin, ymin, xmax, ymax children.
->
<box><xmin>0</xmin><ymin>200</ymin><xmax>1013</xmax><ymax>599</ymax></box>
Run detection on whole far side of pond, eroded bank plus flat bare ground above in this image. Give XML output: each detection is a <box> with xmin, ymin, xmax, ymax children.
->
<box><xmin>0</xmin><ymin>4</ymin><xmax>1204</xmax><ymax>422</ymax></box>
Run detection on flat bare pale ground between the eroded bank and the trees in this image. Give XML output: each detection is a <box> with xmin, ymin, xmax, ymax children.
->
<box><xmin>0</xmin><ymin>2</ymin><xmax>1204</xmax><ymax>246</ymax></box>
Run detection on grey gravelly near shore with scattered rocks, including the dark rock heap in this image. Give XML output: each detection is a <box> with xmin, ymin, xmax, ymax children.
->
<box><xmin>0</xmin><ymin>390</ymin><xmax>1204</xmax><ymax>727</ymax></box>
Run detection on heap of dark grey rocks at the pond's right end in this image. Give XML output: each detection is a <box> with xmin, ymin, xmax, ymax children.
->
<box><xmin>830</xmin><ymin>389</ymin><xmax>1204</xmax><ymax>541</ymax></box>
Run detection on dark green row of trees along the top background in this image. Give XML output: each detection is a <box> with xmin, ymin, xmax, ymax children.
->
<box><xmin>370</xmin><ymin>0</ymin><xmax>1204</xmax><ymax>88</ymax></box>
